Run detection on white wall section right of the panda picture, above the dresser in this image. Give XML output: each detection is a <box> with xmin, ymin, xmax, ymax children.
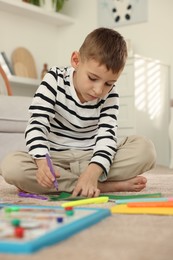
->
<box><xmin>117</xmin><ymin>0</ymin><xmax>173</xmax><ymax>97</ymax></box>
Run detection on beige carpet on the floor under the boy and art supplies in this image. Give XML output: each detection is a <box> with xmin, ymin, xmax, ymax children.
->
<box><xmin>0</xmin><ymin>166</ymin><xmax>173</xmax><ymax>260</ymax></box>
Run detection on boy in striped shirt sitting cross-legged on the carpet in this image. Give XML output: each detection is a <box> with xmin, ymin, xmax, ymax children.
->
<box><xmin>1</xmin><ymin>28</ymin><xmax>156</xmax><ymax>197</ymax></box>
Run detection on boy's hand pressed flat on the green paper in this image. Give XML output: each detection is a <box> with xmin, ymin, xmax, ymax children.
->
<box><xmin>72</xmin><ymin>164</ymin><xmax>102</xmax><ymax>198</ymax></box>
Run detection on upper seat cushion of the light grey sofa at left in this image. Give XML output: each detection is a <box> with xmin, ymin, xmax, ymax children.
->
<box><xmin>0</xmin><ymin>96</ymin><xmax>32</xmax><ymax>133</ymax></box>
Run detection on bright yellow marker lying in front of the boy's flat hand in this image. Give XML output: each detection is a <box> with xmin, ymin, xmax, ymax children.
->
<box><xmin>61</xmin><ymin>197</ymin><xmax>109</xmax><ymax>207</ymax></box>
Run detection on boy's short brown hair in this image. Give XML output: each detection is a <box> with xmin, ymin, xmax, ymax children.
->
<box><xmin>79</xmin><ymin>27</ymin><xmax>127</xmax><ymax>73</ymax></box>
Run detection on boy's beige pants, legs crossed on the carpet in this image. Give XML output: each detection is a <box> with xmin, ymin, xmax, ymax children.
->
<box><xmin>1</xmin><ymin>136</ymin><xmax>156</xmax><ymax>193</ymax></box>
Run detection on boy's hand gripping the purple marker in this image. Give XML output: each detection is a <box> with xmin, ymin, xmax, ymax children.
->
<box><xmin>35</xmin><ymin>159</ymin><xmax>60</xmax><ymax>188</ymax></box>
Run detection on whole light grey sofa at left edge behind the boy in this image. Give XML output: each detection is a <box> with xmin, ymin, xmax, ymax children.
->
<box><xmin>0</xmin><ymin>95</ymin><xmax>32</xmax><ymax>161</ymax></box>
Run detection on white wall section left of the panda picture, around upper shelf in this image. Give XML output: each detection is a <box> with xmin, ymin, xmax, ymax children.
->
<box><xmin>0</xmin><ymin>0</ymin><xmax>97</xmax><ymax>76</ymax></box>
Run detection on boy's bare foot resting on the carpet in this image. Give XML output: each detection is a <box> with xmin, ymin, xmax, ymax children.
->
<box><xmin>98</xmin><ymin>176</ymin><xmax>147</xmax><ymax>193</ymax></box>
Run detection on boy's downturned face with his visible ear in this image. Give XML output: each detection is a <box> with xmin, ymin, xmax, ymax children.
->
<box><xmin>71</xmin><ymin>52</ymin><xmax>121</xmax><ymax>103</ymax></box>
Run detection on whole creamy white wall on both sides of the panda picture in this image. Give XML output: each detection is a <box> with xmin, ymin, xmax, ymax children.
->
<box><xmin>0</xmin><ymin>0</ymin><xmax>173</xmax><ymax>166</ymax></box>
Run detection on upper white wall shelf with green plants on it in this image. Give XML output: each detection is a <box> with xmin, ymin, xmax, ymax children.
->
<box><xmin>0</xmin><ymin>0</ymin><xmax>74</xmax><ymax>26</ymax></box>
